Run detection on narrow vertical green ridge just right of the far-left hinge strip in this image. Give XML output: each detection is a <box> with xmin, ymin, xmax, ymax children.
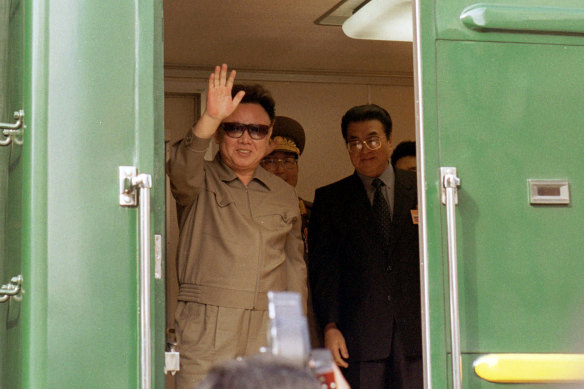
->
<box><xmin>21</xmin><ymin>0</ymin><xmax>50</xmax><ymax>388</ymax></box>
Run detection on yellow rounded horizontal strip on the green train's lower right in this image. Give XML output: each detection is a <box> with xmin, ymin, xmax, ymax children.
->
<box><xmin>473</xmin><ymin>354</ymin><xmax>584</xmax><ymax>384</ymax></box>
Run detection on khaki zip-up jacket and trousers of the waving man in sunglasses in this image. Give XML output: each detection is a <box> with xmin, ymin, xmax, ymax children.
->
<box><xmin>168</xmin><ymin>132</ymin><xmax>307</xmax><ymax>388</ymax></box>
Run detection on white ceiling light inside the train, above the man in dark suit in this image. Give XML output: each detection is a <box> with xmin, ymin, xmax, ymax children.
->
<box><xmin>343</xmin><ymin>0</ymin><xmax>414</xmax><ymax>42</ymax></box>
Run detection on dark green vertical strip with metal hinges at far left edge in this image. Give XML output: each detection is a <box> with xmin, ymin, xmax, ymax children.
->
<box><xmin>0</xmin><ymin>1</ymin><xmax>24</xmax><ymax>388</ymax></box>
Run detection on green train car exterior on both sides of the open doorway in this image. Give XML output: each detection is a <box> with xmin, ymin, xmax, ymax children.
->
<box><xmin>0</xmin><ymin>0</ymin><xmax>584</xmax><ymax>389</ymax></box>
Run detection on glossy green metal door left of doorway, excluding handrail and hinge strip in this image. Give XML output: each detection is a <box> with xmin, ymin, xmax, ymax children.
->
<box><xmin>14</xmin><ymin>0</ymin><xmax>164</xmax><ymax>388</ymax></box>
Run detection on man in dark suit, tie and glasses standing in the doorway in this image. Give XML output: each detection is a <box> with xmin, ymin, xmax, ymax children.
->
<box><xmin>308</xmin><ymin>104</ymin><xmax>423</xmax><ymax>389</ymax></box>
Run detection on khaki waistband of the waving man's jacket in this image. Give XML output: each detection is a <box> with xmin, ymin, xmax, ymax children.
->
<box><xmin>178</xmin><ymin>284</ymin><xmax>268</xmax><ymax>311</ymax></box>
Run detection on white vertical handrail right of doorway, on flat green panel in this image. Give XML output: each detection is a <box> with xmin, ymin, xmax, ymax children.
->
<box><xmin>440</xmin><ymin>167</ymin><xmax>462</xmax><ymax>389</ymax></box>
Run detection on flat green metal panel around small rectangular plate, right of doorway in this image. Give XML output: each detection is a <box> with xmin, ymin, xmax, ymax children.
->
<box><xmin>437</xmin><ymin>42</ymin><xmax>584</xmax><ymax>352</ymax></box>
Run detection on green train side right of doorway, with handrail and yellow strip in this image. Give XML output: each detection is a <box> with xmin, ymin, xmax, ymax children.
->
<box><xmin>414</xmin><ymin>0</ymin><xmax>584</xmax><ymax>389</ymax></box>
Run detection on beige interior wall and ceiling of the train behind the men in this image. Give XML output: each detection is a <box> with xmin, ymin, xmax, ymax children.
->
<box><xmin>164</xmin><ymin>0</ymin><xmax>415</xmax><ymax>387</ymax></box>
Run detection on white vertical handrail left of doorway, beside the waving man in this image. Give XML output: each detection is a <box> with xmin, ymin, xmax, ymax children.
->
<box><xmin>118</xmin><ymin>166</ymin><xmax>152</xmax><ymax>389</ymax></box>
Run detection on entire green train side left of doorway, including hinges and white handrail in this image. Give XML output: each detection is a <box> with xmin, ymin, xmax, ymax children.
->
<box><xmin>0</xmin><ymin>0</ymin><xmax>164</xmax><ymax>389</ymax></box>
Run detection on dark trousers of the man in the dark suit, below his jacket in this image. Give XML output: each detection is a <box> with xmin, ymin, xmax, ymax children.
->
<box><xmin>341</xmin><ymin>327</ymin><xmax>424</xmax><ymax>389</ymax></box>
